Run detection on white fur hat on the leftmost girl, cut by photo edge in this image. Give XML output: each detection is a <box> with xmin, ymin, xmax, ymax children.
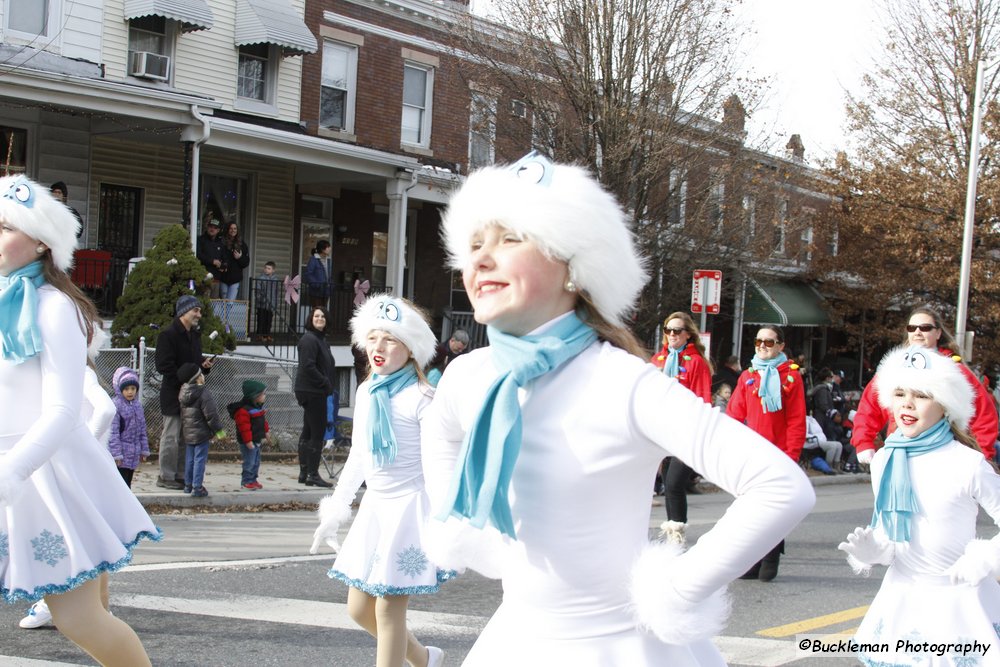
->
<box><xmin>0</xmin><ymin>176</ymin><xmax>80</xmax><ymax>271</ymax></box>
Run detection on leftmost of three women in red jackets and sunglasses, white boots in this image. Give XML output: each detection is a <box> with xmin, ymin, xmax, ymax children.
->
<box><xmin>650</xmin><ymin>311</ymin><xmax>713</xmax><ymax>544</ymax></box>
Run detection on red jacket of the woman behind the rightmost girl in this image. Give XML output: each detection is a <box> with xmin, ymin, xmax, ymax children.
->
<box><xmin>851</xmin><ymin>347</ymin><xmax>997</xmax><ymax>461</ymax></box>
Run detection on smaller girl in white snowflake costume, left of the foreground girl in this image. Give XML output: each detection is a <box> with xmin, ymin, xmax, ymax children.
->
<box><xmin>310</xmin><ymin>294</ymin><xmax>450</xmax><ymax>667</ymax></box>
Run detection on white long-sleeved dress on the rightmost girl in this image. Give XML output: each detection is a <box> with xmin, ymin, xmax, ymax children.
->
<box><xmin>855</xmin><ymin>441</ymin><xmax>1000</xmax><ymax>666</ymax></box>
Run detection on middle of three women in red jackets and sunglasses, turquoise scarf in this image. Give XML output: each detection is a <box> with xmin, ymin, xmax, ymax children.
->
<box><xmin>726</xmin><ymin>325</ymin><xmax>806</xmax><ymax>581</ymax></box>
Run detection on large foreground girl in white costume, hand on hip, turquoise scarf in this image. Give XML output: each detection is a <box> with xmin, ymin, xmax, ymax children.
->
<box><xmin>422</xmin><ymin>154</ymin><xmax>815</xmax><ymax>667</ymax></box>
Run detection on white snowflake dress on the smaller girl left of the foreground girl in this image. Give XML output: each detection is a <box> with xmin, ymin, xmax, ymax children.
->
<box><xmin>328</xmin><ymin>381</ymin><xmax>453</xmax><ymax>597</ymax></box>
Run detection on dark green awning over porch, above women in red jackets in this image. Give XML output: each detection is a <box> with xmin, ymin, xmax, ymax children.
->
<box><xmin>743</xmin><ymin>278</ymin><xmax>830</xmax><ymax>327</ymax></box>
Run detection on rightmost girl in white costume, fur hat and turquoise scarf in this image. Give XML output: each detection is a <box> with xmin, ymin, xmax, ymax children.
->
<box><xmin>838</xmin><ymin>346</ymin><xmax>1000</xmax><ymax>666</ymax></box>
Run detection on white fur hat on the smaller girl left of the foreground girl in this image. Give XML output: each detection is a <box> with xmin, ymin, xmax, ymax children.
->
<box><xmin>351</xmin><ymin>294</ymin><xmax>437</xmax><ymax>370</ymax></box>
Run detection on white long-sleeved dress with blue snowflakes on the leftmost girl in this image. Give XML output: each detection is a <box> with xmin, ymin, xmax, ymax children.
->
<box><xmin>0</xmin><ymin>286</ymin><xmax>161</xmax><ymax>602</ymax></box>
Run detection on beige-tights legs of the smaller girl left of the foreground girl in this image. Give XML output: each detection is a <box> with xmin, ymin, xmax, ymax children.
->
<box><xmin>347</xmin><ymin>588</ymin><xmax>428</xmax><ymax>667</ymax></box>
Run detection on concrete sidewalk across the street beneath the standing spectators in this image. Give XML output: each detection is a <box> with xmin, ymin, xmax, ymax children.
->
<box><xmin>132</xmin><ymin>458</ymin><xmax>871</xmax><ymax>509</ymax></box>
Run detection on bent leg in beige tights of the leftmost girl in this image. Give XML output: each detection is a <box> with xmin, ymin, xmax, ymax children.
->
<box><xmin>45</xmin><ymin>574</ymin><xmax>150</xmax><ymax>667</ymax></box>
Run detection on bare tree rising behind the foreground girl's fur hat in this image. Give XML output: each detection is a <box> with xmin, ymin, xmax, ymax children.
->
<box><xmin>446</xmin><ymin>0</ymin><xmax>760</xmax><ymax>344</ymax></box>
